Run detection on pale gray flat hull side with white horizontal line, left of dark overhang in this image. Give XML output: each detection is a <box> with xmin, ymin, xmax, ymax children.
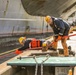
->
<box><xmin>0</xmin><ymin>0</ymin><xmax>50</xmax><ymax>36</ymax></box>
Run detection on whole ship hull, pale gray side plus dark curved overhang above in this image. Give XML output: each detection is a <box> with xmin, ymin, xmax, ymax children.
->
<box><xmin>0</xmin><ymin>0</ymin><xmax>76</xmax><ymax>36</ymax></box>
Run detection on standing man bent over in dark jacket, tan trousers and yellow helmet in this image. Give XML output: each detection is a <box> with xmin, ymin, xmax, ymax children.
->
<box><xmin>45</xmin><ymin>16</ymin><xmax>70</xmax><ymax>56</ymax></box>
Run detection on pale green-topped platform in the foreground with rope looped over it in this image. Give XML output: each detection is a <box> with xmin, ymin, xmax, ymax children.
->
<box><xmin>7</xmin><ymin>54</ymin><xmax>76</xmax><ymax>75</ymax></box>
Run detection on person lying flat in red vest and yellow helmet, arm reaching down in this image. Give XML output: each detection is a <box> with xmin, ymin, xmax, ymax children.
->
<box><xmin>15</xmin><ymin>37</ymin><xmax>44</xmax><ymax>54</ymax></box>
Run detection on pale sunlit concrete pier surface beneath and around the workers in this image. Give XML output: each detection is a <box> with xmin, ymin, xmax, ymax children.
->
<box><xmin>0</xmin><ymin>32</ymin><xmax>76</xmax><ymax>75</ymax></box>
